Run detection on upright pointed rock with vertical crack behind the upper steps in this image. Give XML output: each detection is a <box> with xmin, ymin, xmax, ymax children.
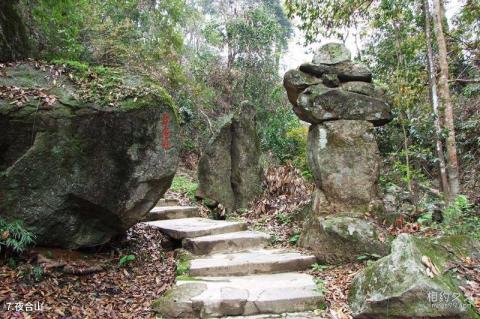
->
<box><xmin>196</xmin><ymin>102</ymin><xmax>262</xmax><ymax>212</ymax></box>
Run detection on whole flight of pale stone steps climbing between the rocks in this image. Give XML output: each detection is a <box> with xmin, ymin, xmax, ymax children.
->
<box><xmin>142</xmin><ymin>201</ymin><xmax>325</xmax><ymax>318</ymax></box>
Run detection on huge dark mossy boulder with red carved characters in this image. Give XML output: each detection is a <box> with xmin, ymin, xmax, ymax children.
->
<box><xmin>0</xmin><ymin>64</ymin><xmax>180</xmax><ymax>248</ymax></box>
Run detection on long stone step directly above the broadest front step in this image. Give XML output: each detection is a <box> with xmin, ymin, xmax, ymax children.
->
<box><xmin>189</xmin><ymin>249</ymin><xmax>316</xmax><ymax>276</ymax></box>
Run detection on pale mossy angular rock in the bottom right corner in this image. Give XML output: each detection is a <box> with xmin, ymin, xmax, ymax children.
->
<box><xmin>349</xmin><ymin>234</ymin><xmax>479</xmax><ymax>319</ymax></box>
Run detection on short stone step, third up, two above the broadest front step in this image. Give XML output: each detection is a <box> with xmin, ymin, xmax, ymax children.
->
<box><xmin>183</xmin><ymin>230</ymin><xmax>270</xmax><ymax>255</ymax></box>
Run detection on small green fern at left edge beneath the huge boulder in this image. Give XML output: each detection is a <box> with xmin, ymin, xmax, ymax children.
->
<box><xmin>0</xmin><ymin>217</ymin><xmax>35</xmax><ymax>257</ymax></box>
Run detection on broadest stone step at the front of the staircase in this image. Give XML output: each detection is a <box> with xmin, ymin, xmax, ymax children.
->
<box><xmin>152</xmin><ymin>273</ymin><xmax>325</xmax><ymax>318</ymax></box>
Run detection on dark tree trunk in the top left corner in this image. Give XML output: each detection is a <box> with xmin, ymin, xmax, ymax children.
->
<box><xmin>0</xmin><ymin>0</ymin><xmax>29</xmax><ymax>62</ymax></box>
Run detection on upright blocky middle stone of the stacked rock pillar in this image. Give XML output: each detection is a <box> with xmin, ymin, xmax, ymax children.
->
<box><xmin>307</xmin><ymin>120</ymin><xmax>381</xmax><ymax>215</ymax></box>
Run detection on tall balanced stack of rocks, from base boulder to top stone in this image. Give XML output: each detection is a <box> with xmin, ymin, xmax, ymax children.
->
<box><xmin>284</xmin><ymin>43</ymin><xmax>392</xmax><ymax>264</ymax></box>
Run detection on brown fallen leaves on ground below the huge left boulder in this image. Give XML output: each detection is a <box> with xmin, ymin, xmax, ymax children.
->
<box><xmin>0</xmin><ymin>225</ymin><xmax>175</xmax><ymax>319</ymax></box>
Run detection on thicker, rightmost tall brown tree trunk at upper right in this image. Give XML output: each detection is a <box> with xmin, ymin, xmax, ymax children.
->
<box><xmin>433</xmin><ymin>0</ymin><xmax>460</xmax><ymax>202</ymax></box>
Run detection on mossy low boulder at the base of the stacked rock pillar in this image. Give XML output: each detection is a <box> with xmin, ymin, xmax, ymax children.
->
<box><xmin>299</xmin><ymin>215</ymin><xmax>390</xmax><ymax>264</ymax></box>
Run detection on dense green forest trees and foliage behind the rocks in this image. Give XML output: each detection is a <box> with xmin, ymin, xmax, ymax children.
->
<box><xmin>5</xmin><ymin>0</ymin><xmax>480</xmax><ymax>211</ymax></box>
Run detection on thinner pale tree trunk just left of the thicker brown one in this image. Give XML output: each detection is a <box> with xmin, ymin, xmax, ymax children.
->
<box><xmin>422</xmin><ymin>0</ymin><xmax>450</xmax><ymax>201</ymax></box>
